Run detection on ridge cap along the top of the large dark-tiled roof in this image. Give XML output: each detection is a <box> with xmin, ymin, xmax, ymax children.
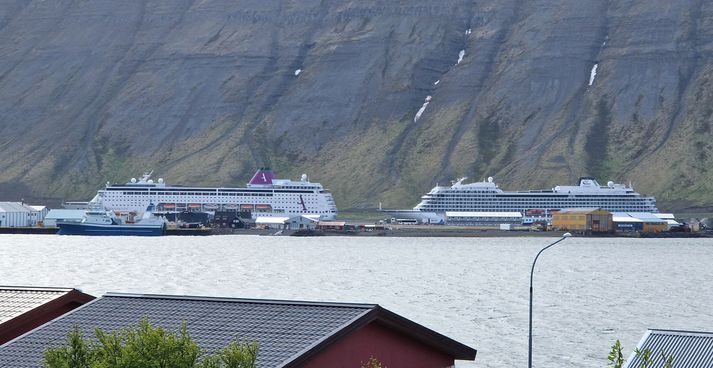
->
<box><xmin>102</xmin><ymin>292</ymin><xmax>379</xmax><ymax>309</ymax></box>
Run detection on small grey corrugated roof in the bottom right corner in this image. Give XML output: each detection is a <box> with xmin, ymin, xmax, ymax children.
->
<box><xmin>626</xmin><ymin>329</ymin><xmax>713</xmax><ymax>368</ymax></box>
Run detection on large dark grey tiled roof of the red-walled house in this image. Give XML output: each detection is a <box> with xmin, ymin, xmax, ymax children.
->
<box><xmin>0</xmin><ymin>294</ymin><xmax>475</xmax><ymax>368</ymax></box>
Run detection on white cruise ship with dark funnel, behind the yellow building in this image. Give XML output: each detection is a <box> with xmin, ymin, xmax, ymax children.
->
<box><xmin>384</xmin><ymin>177</ymin><xmax>659</xmax><ymax>224</ymax></box>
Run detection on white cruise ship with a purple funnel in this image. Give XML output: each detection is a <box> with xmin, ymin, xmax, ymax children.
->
<box><xmin>85</xmin><ymin>168</ymin><xmax>337</xmax><ymax>220</ymax></box>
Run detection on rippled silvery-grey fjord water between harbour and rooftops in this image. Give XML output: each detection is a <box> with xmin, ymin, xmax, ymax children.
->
<box><xmin>0</xmin><ymin>235</ymin><xmax>713</xmax><ymax>368</ymax></box>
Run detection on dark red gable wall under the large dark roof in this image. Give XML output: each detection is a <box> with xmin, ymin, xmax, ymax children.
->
<box><xmin>304</xmin><ymin>322</ymin><xmax>453</xmax><ymax>368</ymax></box>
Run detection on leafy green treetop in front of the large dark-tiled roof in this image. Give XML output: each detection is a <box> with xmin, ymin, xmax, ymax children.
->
<box><xmin>44</xmin><ymin>319</ymin><xmax>258</xmax><ymax>368</ymax></box>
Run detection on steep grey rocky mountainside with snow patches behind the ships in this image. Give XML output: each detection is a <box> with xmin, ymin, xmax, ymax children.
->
<box><xmin>0</xmin><ymin>0</ymin><xmax>713</xmax><ymax>210</ymax></box>
